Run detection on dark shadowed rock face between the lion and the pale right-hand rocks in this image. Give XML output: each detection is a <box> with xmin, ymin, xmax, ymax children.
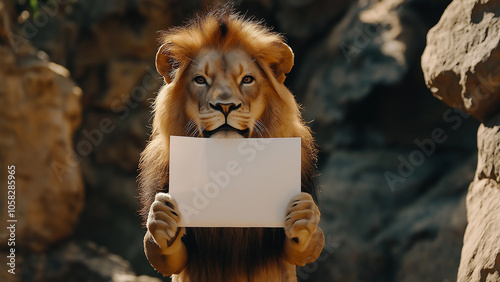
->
<box><xmin>293</xmin><ymin>1</ymin><xmax>476</xmax><ymax>281</ymax></box>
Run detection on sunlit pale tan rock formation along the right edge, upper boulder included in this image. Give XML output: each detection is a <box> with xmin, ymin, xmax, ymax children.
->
<box><xmin>422</xmin><ymin>0</ymin><xmax>500</xmax><ymax>281</ymax></box>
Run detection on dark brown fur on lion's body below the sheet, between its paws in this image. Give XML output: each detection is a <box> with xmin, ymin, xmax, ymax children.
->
<box><xmin>173</xmin><ymin>228</ymin><xmax>295</xmax><ymax>281</ymax></box>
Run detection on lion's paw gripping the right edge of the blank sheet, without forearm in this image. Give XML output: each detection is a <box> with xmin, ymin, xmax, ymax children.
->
<box><xmin>285</xmin><ymin>192</ymin><xmax>320</xmax><ymax>249</ymax></box>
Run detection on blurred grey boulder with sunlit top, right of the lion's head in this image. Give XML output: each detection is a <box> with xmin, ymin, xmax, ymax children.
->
<box><xmin>294</xmin><ymin>0</ymin><xmax>424</xmax><ymax>150</ymax></box>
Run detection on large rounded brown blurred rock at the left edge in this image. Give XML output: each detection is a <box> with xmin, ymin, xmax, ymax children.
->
<box><xmin>0</xmin><ymin>3</ymin><xmax>84</xmax><ymax>251</ymax></box>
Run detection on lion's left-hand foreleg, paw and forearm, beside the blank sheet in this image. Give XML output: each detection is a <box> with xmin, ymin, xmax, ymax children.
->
<box><xmin>144</xmin><ymin>193</ymin><xmax>187</xmax><ymax>276</ymax></box>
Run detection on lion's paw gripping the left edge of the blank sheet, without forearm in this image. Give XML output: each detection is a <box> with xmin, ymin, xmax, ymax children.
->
<box><xmin>146</xmin><ymin>193</ymin><xmax>183</xmax><ymax>250</ymax></box>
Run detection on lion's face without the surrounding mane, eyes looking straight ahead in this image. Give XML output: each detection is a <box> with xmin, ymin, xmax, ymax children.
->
<box><xmin>185</xmin><ymin>49</ymin><xmax>271</xmax><ymax>138</ymax></box>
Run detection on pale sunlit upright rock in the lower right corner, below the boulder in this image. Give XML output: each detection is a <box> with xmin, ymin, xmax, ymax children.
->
<box><xmin>457</xmin><ymin>115</ymin><xmax>500</xmax><ymax>281</ymax></box>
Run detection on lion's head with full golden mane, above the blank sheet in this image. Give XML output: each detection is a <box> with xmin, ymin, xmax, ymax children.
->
<box><xmin>153</xmin><ymin>15</ymin><xmax>300</xmax><ymax>138</ymax></box>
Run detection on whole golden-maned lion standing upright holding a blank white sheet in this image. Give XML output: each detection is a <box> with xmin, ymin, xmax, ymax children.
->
<box><xmin>139</xmin><ymin>9</ymin><xmax>325</xmax><ymax>281</ymax></box>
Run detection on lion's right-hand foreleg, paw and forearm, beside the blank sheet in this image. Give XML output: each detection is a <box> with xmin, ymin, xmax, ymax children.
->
<box><xmin>284</xmin><ymin>192</ymin><xmax>325</xmax><ymax>266</ymax></box>
